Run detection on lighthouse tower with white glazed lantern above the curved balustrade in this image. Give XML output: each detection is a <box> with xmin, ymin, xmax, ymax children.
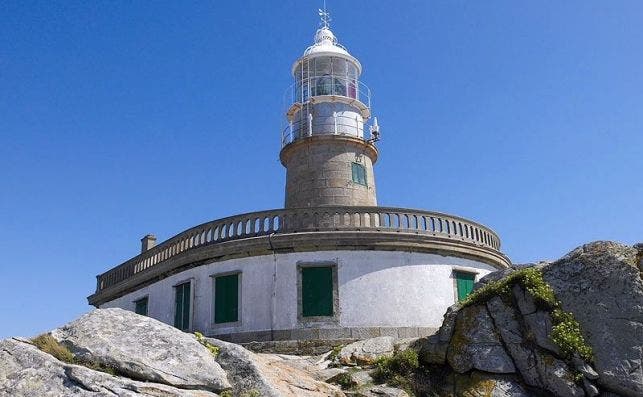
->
<box><xmin>279</xmin><ymin>10</ymin><xmax>379</xmax><ymax>208</ymax></box>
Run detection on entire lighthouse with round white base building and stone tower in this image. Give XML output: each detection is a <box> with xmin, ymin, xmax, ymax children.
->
<box><xmin>88</xmin><ymin>11</ymin><xmax>510</xmax><ymax>342</ymax></box>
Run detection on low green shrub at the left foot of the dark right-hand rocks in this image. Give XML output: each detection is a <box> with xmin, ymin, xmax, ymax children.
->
<box><xmin>372</xmin><ymin>349</ymin><xmax>420</xmax><ymax>395</ymax></box>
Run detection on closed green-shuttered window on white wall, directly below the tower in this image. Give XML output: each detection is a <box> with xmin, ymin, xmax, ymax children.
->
<box><xmin>301</xmin><ymin>266</ymin><xmax>333</xmax><ymax>317</ymax></box>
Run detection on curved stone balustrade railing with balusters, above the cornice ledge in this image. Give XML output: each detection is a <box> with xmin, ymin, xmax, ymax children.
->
<box><xmin>96</xmin><ymin>207</ymin><xmax>500</xmax><ymax>293</ymax></box>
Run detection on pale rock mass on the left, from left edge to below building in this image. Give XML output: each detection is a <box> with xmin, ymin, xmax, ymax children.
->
<box><xmin>0</xmin><ymin>309</ymin><xmax>344</xmax><ymax>397</ymax></box>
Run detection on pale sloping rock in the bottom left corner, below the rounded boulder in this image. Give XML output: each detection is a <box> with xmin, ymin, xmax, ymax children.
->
<box><xmin>0</xmin><ymin>339</ymin><xmax>216</xmax><ymax>397</ymax></box>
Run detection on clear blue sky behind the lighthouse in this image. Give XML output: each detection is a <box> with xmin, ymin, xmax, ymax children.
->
<box><xmin>0</xmin><ymin>0</ymin><xmax>643</xmax><ymax>337</ymax></box>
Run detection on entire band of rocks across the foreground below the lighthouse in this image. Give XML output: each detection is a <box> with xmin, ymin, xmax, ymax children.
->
<box><xmin>0</xmin><ymin>242</ymin><xmax>643</xmax><ymax>397</ymax></box>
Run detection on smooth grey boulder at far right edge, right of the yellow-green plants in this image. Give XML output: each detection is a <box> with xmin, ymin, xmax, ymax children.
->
<box><xmin>543</xmin><ymin>242</ymin><xmax>643</xmax><ymax>397</ymax></box>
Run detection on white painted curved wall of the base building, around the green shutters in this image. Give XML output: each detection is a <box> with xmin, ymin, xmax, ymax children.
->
<box><xmin>101</xmin><ymin>251</ymin><xmax>495</xmax><ymax>334</ymax></box>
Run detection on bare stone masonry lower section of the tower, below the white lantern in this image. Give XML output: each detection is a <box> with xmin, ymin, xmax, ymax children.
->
<box><xmin>280</xmin><ymin>135</ymin><xmax>377</xmax><ymax>208</ymax></box>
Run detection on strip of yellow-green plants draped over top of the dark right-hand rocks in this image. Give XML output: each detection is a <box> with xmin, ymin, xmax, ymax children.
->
<box><xmin>461</xmin><ymin>267</ymin><xmax>592</xmax><ymax>362</ymax></box>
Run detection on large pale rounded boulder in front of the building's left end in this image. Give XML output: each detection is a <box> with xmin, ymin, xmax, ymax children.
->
<box><xmin>51</xmin><ymin>309</ymin><xmax>230</xmax><ymax>391</ymax></box>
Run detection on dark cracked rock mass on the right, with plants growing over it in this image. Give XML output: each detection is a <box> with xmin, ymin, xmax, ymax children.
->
<box><xmin>418</xmin><ymin>242</ymin><xmax>643</xmax><ymax>397</ymax></box>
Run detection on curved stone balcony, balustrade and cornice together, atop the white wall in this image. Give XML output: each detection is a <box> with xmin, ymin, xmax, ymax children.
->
<box><xmin>88</xmin><ymin>207</ymin><xmax>511</xmax><ymax>305</ymax></box>
